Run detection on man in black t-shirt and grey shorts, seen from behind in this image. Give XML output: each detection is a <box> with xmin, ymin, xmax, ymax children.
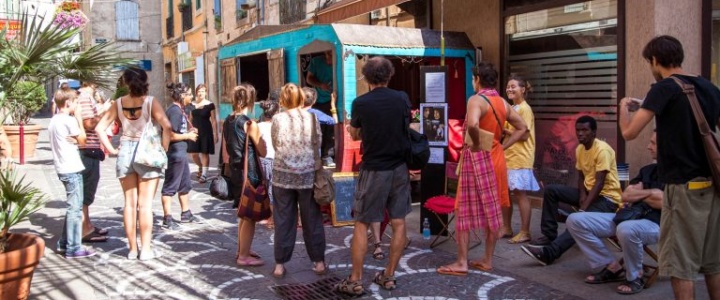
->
<box><xmin>336</xmin><ymin>57</ymin><xmax>411</xmax><ymax>295</ymax></box>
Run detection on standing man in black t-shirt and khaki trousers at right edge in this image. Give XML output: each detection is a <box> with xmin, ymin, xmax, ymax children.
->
<box><xmin>619</xmin><ymin>36</ymin><xmax>720</xmax><ymax>299</ymax></box>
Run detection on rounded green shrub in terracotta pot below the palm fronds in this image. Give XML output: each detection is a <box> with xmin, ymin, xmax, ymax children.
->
<box><xmin>4</xmin><ymin>81</ymin><xmax>46</xmax><ymax>157</ymax></box>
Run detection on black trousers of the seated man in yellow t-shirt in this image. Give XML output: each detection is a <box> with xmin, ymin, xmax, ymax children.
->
<box><xmin>540</xmin><ymin>184</ymin><xmax>618</xmax><ymax>260</ymax></box>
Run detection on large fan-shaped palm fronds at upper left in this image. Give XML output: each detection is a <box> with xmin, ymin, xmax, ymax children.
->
<box><xmin>0</xmin><ymin>11</ymin><xmax>133</xmax><ymax>122</ymax></box>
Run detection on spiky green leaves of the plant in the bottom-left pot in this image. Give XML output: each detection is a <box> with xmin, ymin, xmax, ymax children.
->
<box><xmin>0</xmin><ymin>170</ymin><xmax>47</xmax><ymax>253</ymax></box>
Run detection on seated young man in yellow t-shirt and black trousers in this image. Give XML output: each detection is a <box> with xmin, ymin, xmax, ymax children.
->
<box><xmin>521</xmin><ymin>116</ymin><xmax>622</xmax><ymax>265</ymax></box>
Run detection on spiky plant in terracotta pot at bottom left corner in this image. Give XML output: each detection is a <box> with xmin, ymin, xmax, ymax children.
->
<box><xmin>0</xmin><ymin>170</ymin><xmax>46</xmax><ymax>300</ymax></box>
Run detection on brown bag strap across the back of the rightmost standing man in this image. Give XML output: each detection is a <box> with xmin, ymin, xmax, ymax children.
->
<box><xmin>670</xmin><ymin>76</ymin><xmax>720</xmax><ymax>193</ymax></box>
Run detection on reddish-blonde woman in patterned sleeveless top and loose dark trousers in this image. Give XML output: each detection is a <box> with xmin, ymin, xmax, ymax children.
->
<box><xmin>271</xmin><ymin>83</ymin><xmax>327</xmax><ymax>278</ymax></box>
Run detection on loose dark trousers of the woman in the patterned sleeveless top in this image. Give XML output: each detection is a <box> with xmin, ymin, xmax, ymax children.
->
<box><xmin>272</xmin><ymin>186</ymin><xmax>325</xmax><ymax>264</ymax></box>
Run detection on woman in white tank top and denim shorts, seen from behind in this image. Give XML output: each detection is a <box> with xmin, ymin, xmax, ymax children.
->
<box><xmin>95</xmin><ymin>68</ymin><xmax>172</xmax><ymax>260</ymax></box>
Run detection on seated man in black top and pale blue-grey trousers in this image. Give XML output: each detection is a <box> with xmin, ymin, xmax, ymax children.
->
<box><xmin>566</xmin><ymin>134</ymin><xmax>663</xmax><ymax>294</ymax></box>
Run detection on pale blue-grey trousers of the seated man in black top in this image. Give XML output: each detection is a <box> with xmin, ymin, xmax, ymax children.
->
<box><xmin>565</xmin><ymin>212</ymin><xmax>660</xmax><ymax>281</ymax></box>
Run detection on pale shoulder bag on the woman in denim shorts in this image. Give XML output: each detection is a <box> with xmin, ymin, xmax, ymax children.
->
<box><xmin>133</xmin><ymin>97</ymin><xmax>167</xmax><ymax>169</ymax></box>
